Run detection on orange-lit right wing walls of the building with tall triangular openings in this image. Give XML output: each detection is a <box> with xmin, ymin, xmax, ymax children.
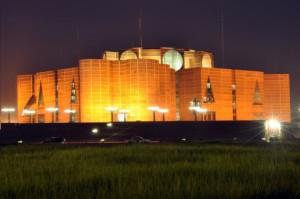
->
<box><xmin>178</xmin><ymin>68</ymin><xmax>290</xmax><ymax>122</ymax></box>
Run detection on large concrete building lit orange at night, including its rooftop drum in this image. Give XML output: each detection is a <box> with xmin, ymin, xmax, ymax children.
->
<box><xmin>17</xmin><ymin>48</ymin><xmax>291</xmax><ymax>123</ymax></box>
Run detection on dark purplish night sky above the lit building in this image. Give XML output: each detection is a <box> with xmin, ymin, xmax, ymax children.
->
<box><xmin>0</xmin><ymin>0</ymin><xmax>300</xmax><ymax>119</ymax></box>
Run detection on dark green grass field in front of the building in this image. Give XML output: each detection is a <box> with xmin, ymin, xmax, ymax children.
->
<box><xmin>0</xmin><ymin>143</ymin><xmax>300</xmax><ymax>199</ymax></box>
